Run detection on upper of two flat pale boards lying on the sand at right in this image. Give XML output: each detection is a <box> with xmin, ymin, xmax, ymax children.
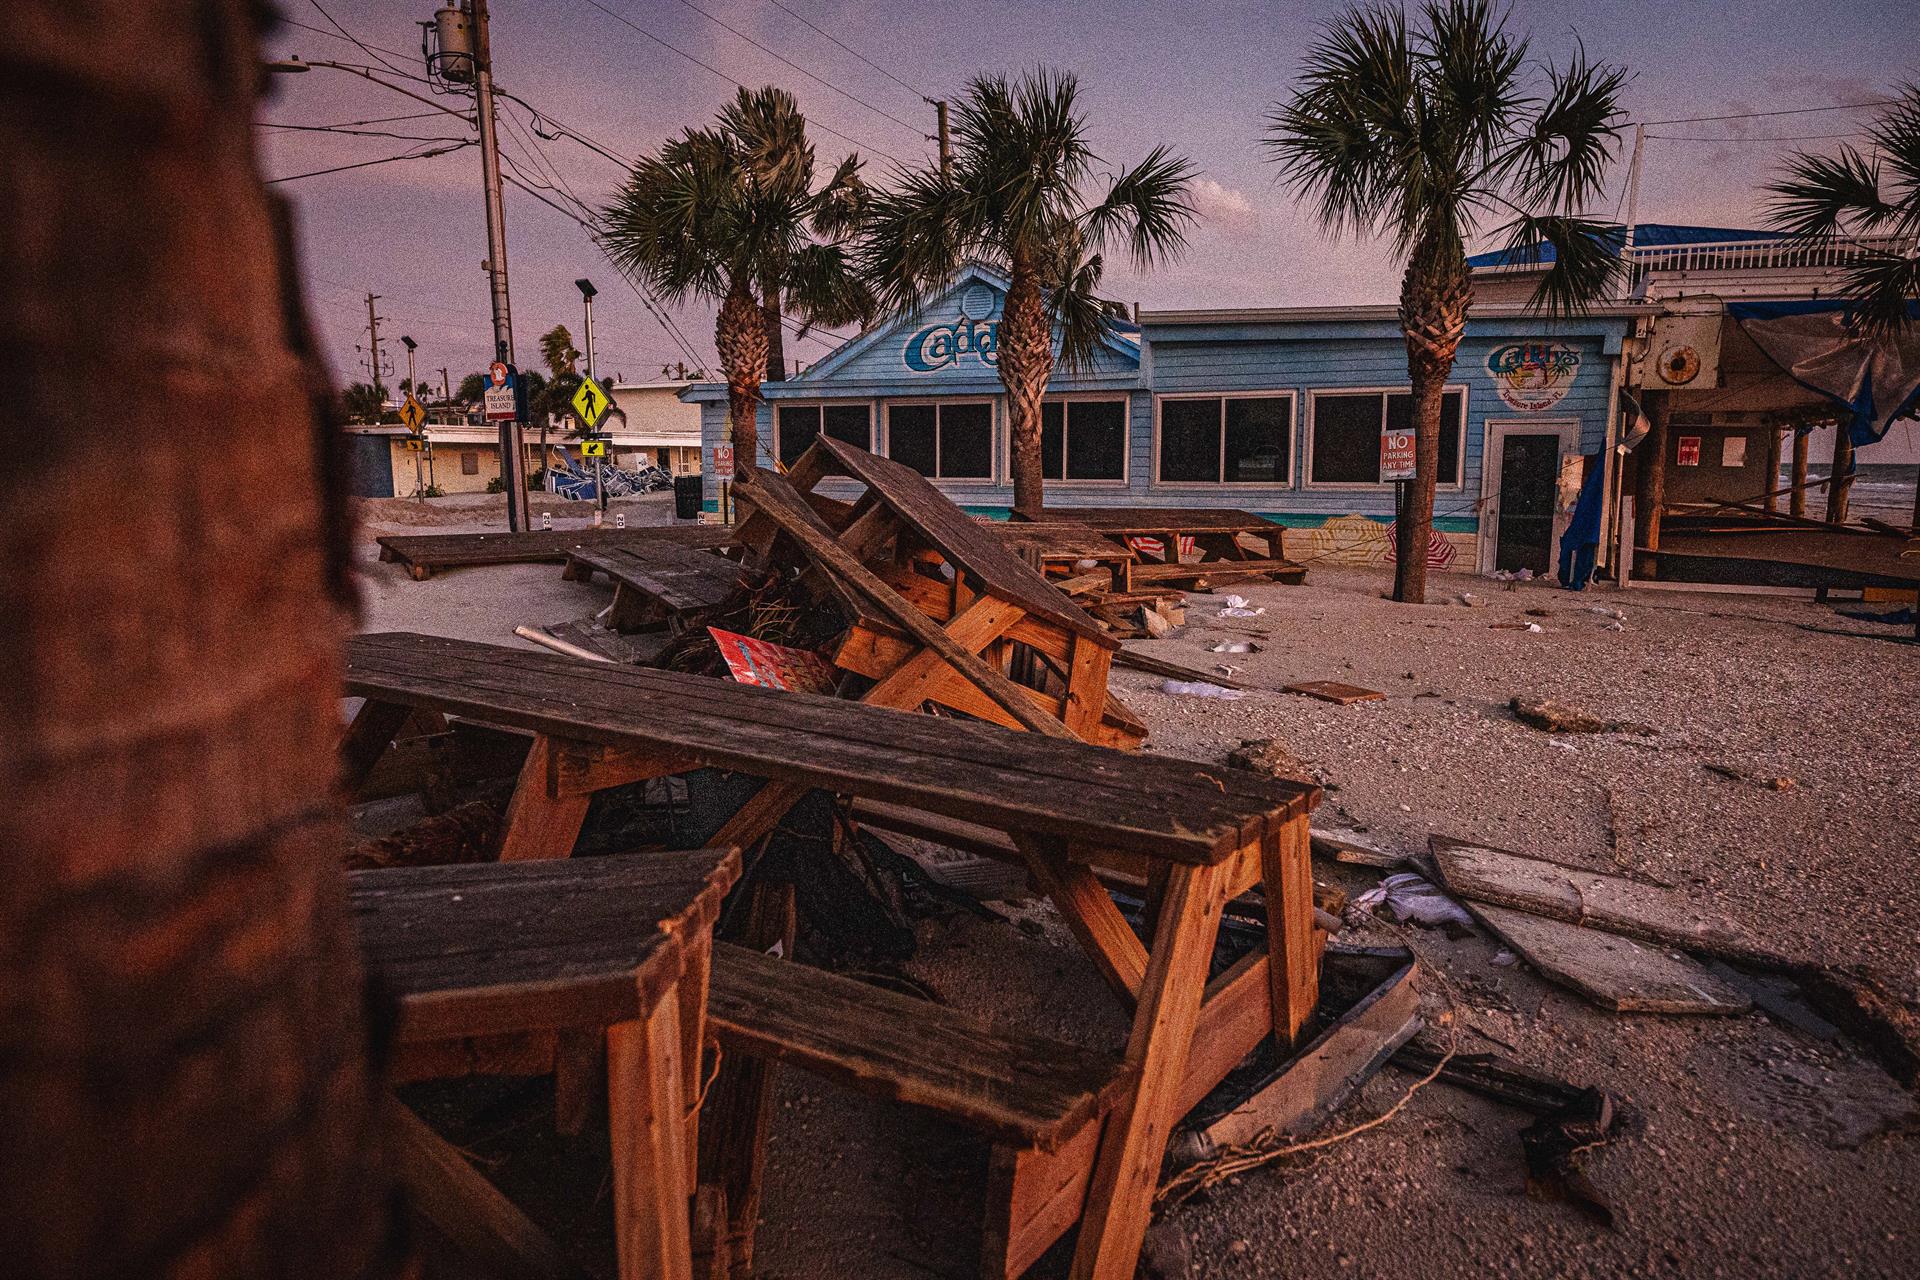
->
<box><xmin>1430</xmin><ymin>835</ymin><xmax>1759</xmax><ymax>952</ymax></box>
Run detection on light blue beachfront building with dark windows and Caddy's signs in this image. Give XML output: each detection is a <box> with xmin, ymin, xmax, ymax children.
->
<box><xmin>684</xmin><ymin>267</ymin><xmax>1647</xmax><ymax>570</ymax></box>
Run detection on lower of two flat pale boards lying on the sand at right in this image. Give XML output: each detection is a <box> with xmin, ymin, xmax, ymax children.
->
<box><xmin>1467</xmin><ymin>902</ymin><xmax>1753</xmax><ymax>1013</ymax></box>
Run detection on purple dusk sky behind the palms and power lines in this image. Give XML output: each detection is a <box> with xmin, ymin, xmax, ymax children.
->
<box><xmin>259</xmin><ymin>0</ymin><xmax>1920</xmax><ymax>391</ymax></box>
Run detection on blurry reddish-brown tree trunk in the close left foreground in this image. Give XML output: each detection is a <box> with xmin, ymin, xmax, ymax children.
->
<box><xmin>0</xmin><ymin>0</ymin><xmax>396</xmax><ymax>1280</ymax></box>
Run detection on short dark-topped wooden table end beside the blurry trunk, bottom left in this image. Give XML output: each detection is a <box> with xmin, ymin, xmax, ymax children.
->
<box><xmin>348</xmin><ymin>848</ymin><xmax>739</xmax><ymax>1280</ymax></box>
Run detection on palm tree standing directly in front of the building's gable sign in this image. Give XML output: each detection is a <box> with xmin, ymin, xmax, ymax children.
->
<box><xmin>862</xmin><ymin>67</ymin><xmax>1194</xmax><ymax>510</ymax></box>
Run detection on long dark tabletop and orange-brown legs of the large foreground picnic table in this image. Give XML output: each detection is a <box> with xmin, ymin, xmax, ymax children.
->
<box><xmin>344</xmin><ymin>633</ymin><xmax>1325</xmax><ymax>1280</ymax></box>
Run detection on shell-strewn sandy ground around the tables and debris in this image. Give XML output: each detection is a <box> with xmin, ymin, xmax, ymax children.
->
<box><xmin>349</xmin><ymin>497</ymin><xmax>1920</xmax><ymax>1280</ymax></box>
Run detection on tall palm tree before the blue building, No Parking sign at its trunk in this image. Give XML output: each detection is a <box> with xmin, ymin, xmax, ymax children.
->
<box><xmin>1265</xmin><ymin>0</ymin><xmax>1626</xmax><ymax>603</ymax></box>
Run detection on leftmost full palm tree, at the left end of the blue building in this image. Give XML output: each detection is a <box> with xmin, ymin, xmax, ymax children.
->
<box><xmin>601</xmin><ymin>88</ymin><xmax>872</xmax><ymax>472</ymax></box>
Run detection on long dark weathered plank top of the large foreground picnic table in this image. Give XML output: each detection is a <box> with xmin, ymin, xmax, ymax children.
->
<box><xmin>346</xmin><ymin>633</ymin><xmax>1317</xmax><ymax>864</ymax></box>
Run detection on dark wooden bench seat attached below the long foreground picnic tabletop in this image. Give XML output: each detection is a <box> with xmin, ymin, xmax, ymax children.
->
<box><xmin>707</xmin><ymin>942</ymin><xmax>1131</xmax><ymax>1150</ymax></box>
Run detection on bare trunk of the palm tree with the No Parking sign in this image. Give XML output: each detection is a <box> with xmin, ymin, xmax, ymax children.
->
<box><xmin>1394</xmin><ymin>248</ymin><xmax>1473</xmax><ymax>604</ymax></box>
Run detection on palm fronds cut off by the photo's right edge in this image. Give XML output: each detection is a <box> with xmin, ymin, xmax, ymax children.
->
<box><xmin>1766</xmin><ymin>84</ymin><xmax>1920</xmax><ymax>334</ymax></box>
